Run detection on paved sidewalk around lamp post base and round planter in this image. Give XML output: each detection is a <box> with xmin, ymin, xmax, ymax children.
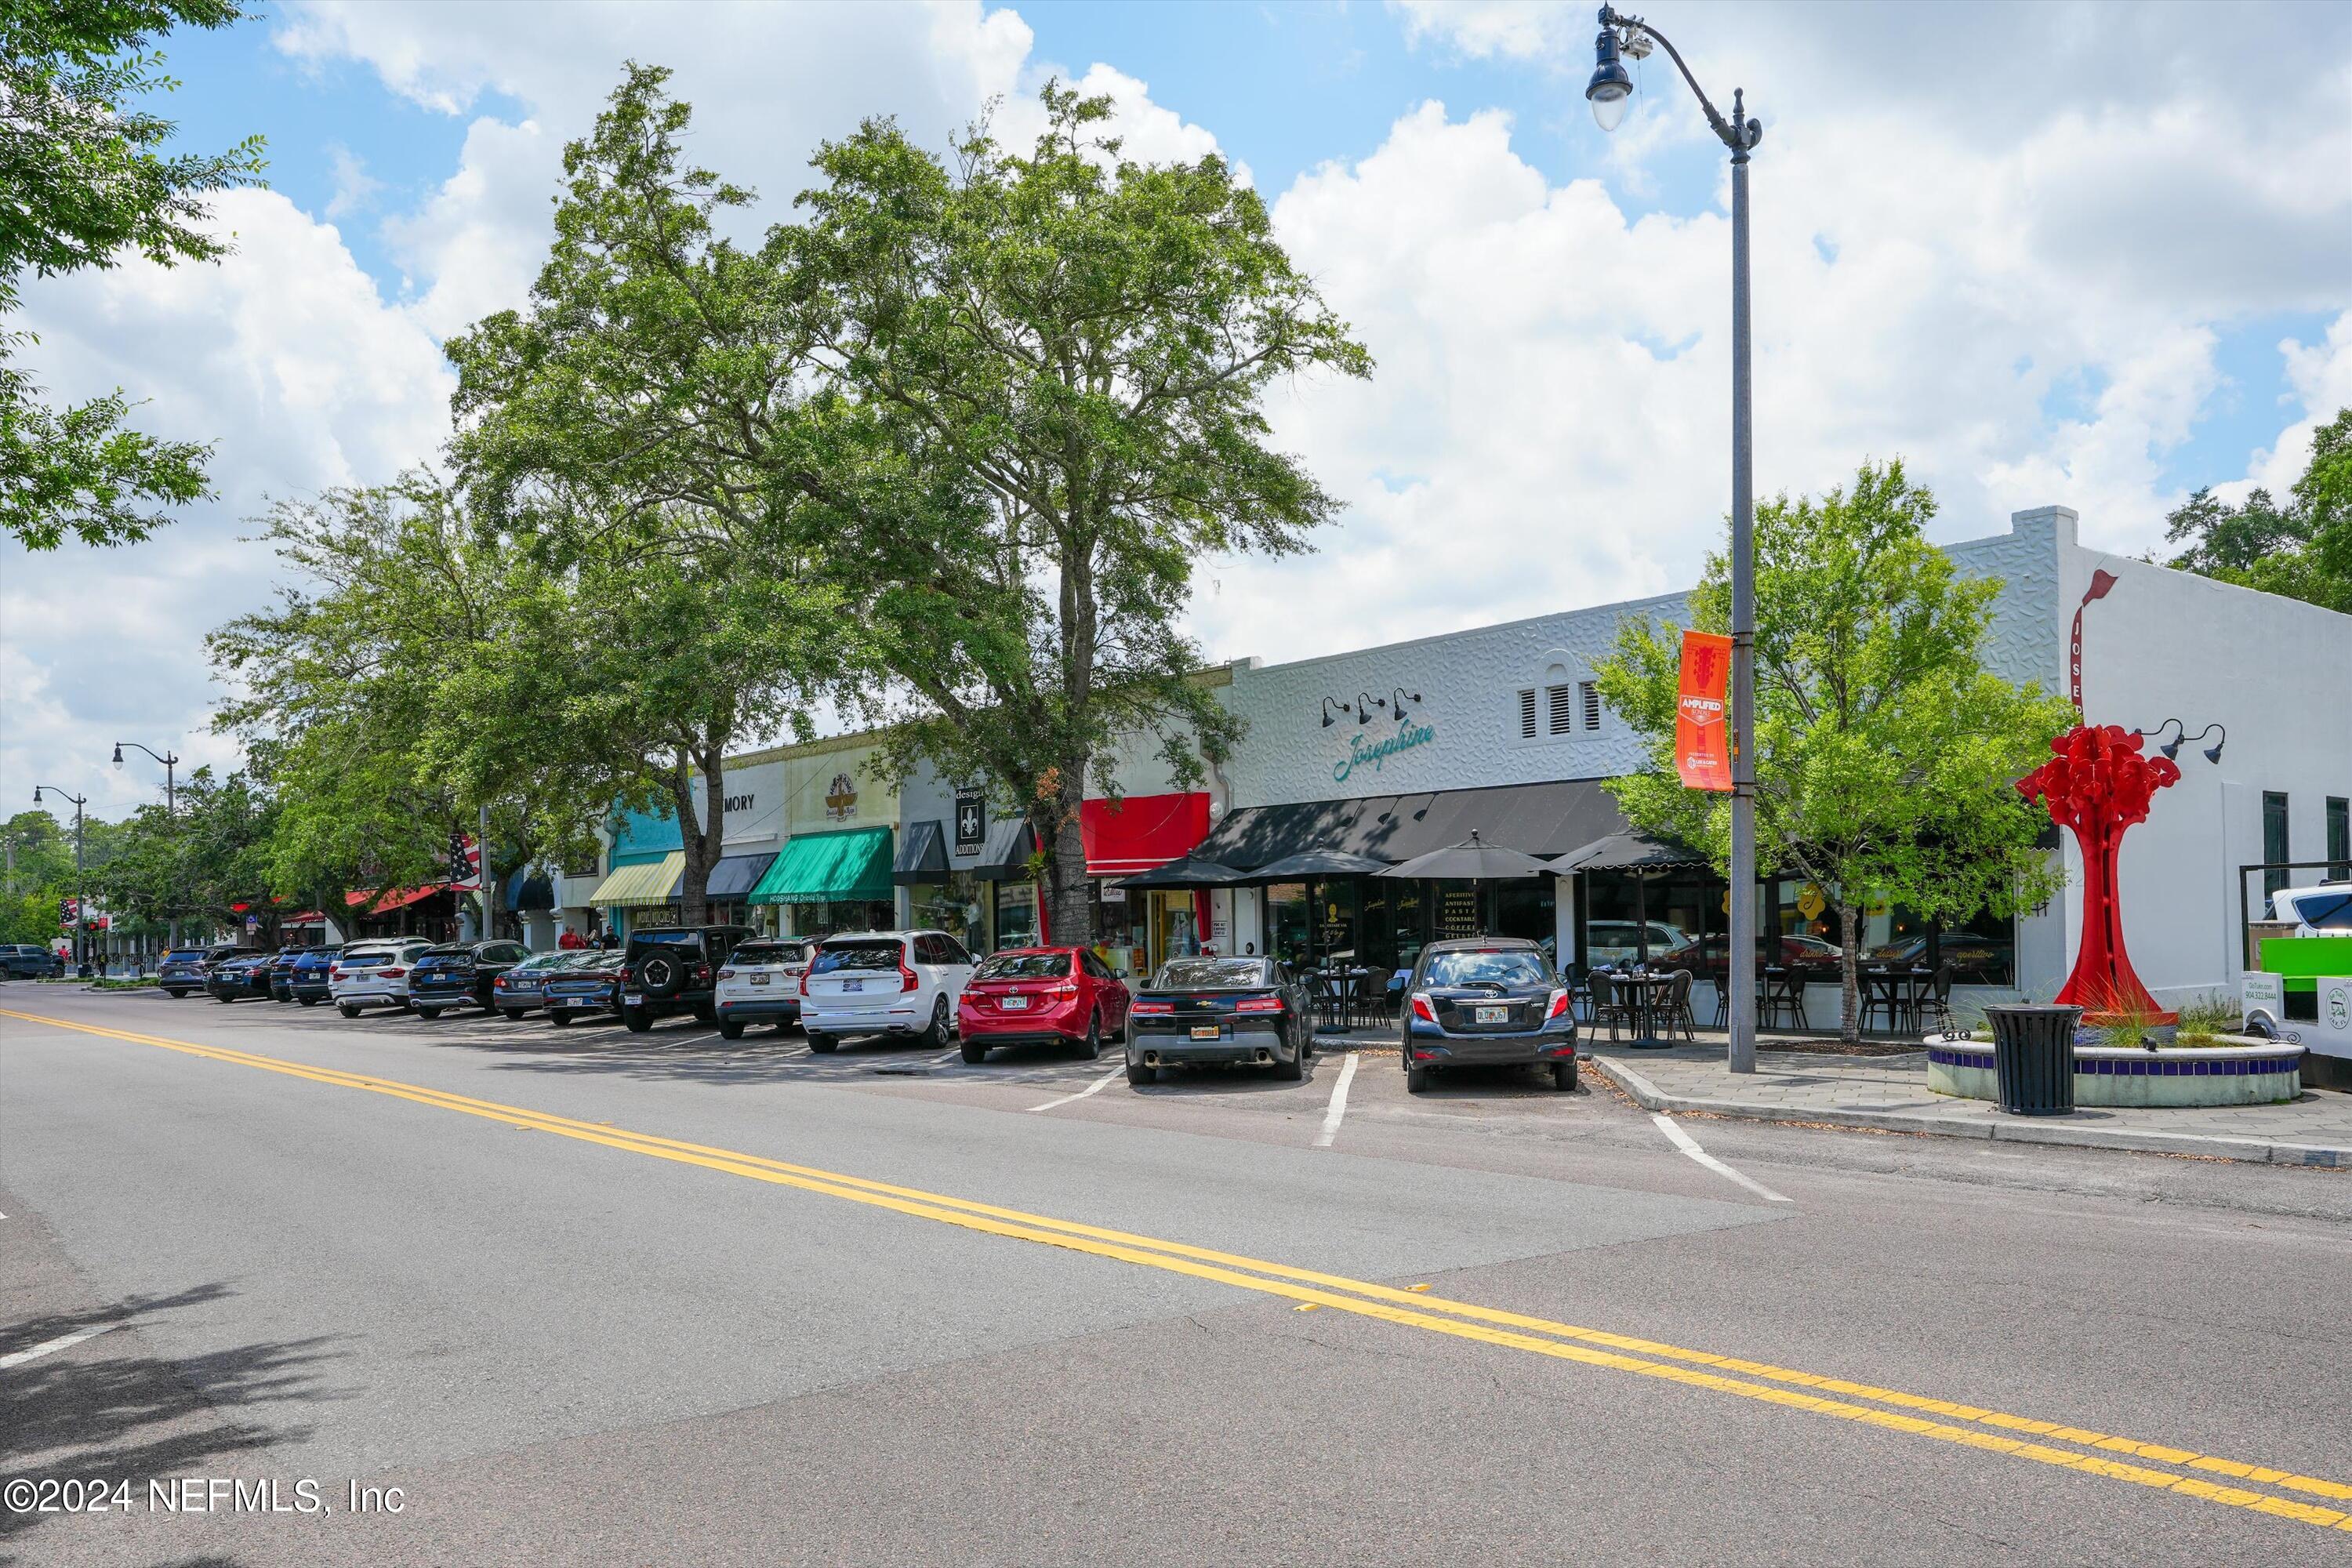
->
<box><xmin>1585</xmin><ymin>1036</ymin><xmax>2352</xmax><ymax>1166</ymax></box>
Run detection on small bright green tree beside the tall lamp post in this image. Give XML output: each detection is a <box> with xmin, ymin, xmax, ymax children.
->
<box><xmin>1599</xmin><ymin>461</ymin><xmax>2074</xmax><ymax>1041</ymax></box>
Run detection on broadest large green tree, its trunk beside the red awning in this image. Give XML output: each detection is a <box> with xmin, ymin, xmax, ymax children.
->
<box><xmin>790</xmin><ymin>82</ymin><xmax>1371</xmax><ymax>940</ymax></box>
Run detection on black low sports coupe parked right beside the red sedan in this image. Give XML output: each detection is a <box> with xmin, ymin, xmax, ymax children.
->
<box><xmin>1127</xmin><ymin>956</ymin><xmax>1315</xmax><ymax>1083</ymax></box>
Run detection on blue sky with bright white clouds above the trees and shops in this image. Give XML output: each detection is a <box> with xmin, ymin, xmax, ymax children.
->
<box><xmin>0</xmin><ymin>0</ymin><xmax>2352</xmax><ymax>815</ymax></box>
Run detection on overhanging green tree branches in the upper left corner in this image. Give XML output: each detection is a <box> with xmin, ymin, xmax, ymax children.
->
<box><xmin>0</xmin><ymin>0</ymin><xmax>261</xmax><ymax>550</ymax></box>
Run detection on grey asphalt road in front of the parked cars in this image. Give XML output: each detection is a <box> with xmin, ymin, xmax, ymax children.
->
<box><xmin>0</xmin><ymin>985</ymin><xmax>2352</xmax><ymax>1568</ymax></box>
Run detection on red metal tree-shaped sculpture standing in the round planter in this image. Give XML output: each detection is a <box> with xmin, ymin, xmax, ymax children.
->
<box><xmin>2018</xmin><ymin>724</ymin><xmax>2180</xmax><ymax>1022</ymax></box>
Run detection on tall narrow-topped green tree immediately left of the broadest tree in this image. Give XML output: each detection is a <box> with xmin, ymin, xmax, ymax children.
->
<box><xmin>449</xmin><ymin>66</ymin><xmax>856</xmax><ymax>924</ymax></box>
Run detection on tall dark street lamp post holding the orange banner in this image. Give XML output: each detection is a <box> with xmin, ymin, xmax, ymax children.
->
<box><xmin>1585</xmin><ymin>5</ymin><xmax>1764</xmax><ymax>1072</ymax></box>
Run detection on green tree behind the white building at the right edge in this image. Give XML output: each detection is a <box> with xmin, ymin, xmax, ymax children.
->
<box><xmin>2164</xmin><ymin>409</ymin><xmax>2352</xmax><ymax>614</ymax></box>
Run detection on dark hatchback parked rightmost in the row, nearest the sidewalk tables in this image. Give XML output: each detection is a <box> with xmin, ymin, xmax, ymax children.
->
<box><xmin>1399</xmin><ymin>935</ymin><xmax>1576</xmax><ymax>1093</ymax></box>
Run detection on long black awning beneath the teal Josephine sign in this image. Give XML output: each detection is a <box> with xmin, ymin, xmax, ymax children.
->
<box><xmin>1192</xmin><ymin>779</ymin><xmax>1625</xmax><ymax>869</ymax></box>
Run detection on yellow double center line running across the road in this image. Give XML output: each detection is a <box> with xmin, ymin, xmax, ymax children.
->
<box><xmin>0</xmin><ymin>1008</ymin><xmax>2352</xmax><ymax>1533</ymax></box>
